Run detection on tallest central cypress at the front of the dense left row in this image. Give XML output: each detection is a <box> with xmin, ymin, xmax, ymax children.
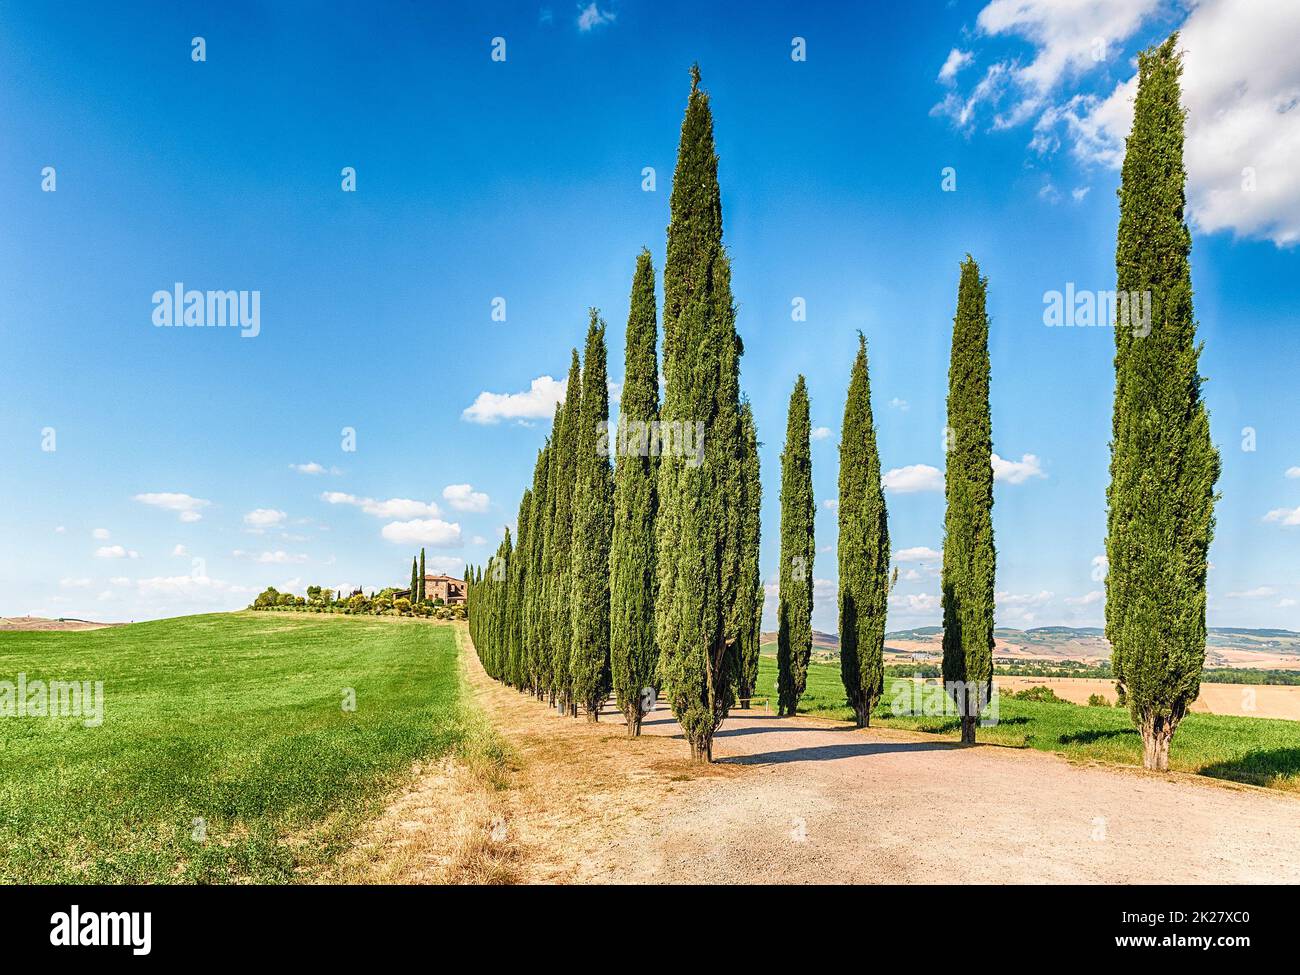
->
<box><xmin>655</xmin><ymin>68</ymin><xmax>742</xmax><ymax>762</ymax></box>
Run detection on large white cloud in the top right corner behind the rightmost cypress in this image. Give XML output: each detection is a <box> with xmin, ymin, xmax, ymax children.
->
<box><xmin>933</xmin><ymin>0</ymin><xmax>1300</xmax><ymax>246</ymax></box>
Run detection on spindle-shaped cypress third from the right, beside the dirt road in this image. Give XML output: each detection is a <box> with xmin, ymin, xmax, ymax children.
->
<box><xmin>837</xmin><ymin>332</ymin><xmax>889</xmax><ymax>728</ymax></box>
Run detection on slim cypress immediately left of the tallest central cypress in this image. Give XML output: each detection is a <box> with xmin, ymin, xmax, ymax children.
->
<box><xmin>610</xmin><ymin>250</ymin><xmax>659</xmax><ymax>736</ymax></box>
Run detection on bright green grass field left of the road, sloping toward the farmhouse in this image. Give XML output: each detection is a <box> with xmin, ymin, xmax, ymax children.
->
<box><xmin>0</xmin><ymin>612</ymin><xmax>477</xmax><ymax>883</ymax></box>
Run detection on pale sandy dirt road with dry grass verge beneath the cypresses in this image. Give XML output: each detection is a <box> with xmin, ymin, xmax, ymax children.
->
<box><xmin>356</xmin><ymin>641</ymin><xmax>1300</xmax><ymax>884</ymax></box>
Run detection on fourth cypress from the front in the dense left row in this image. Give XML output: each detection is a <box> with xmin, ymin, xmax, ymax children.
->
<box><xmin>550</xmin><ymin>348</ymin><xmax>582</xmax><ymax>714</ymax></box>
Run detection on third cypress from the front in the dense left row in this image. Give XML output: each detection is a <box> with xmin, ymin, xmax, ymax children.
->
<box><xmin>569</xmin><ymin>308</ymin><xmax>614</xmax><ymax>722</ymax></box>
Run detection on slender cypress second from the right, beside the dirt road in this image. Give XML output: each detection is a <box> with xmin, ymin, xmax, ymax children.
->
<box><xmin>943</xmin><ymin>254</ymin><xmax>997</xmax><ymax>744</ymax></box>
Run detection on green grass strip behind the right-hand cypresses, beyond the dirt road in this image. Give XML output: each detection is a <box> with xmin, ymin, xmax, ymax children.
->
<box><xmin>757</xmin><ymin>644</ymin><xmax>1300</xmax><ymax>792</ymax></box>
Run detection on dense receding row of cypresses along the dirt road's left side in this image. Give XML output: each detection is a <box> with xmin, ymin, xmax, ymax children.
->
<box><xmin>467</xmin><ymin>68</ymin><xmax>763</xmax><ymax>761</ymax></box>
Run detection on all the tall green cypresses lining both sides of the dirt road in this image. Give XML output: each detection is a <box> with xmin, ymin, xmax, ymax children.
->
<box><xmin>467</xmin><ymin>34</ymin><xmax>1219</xmax><ymax>768</ymax></box>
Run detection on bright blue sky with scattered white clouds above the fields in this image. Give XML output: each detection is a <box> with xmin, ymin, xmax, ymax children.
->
<box><xmin>0</xmin><ymin>0</ymin><xmax>1300</xmax><ymax>631</ymax></box>
